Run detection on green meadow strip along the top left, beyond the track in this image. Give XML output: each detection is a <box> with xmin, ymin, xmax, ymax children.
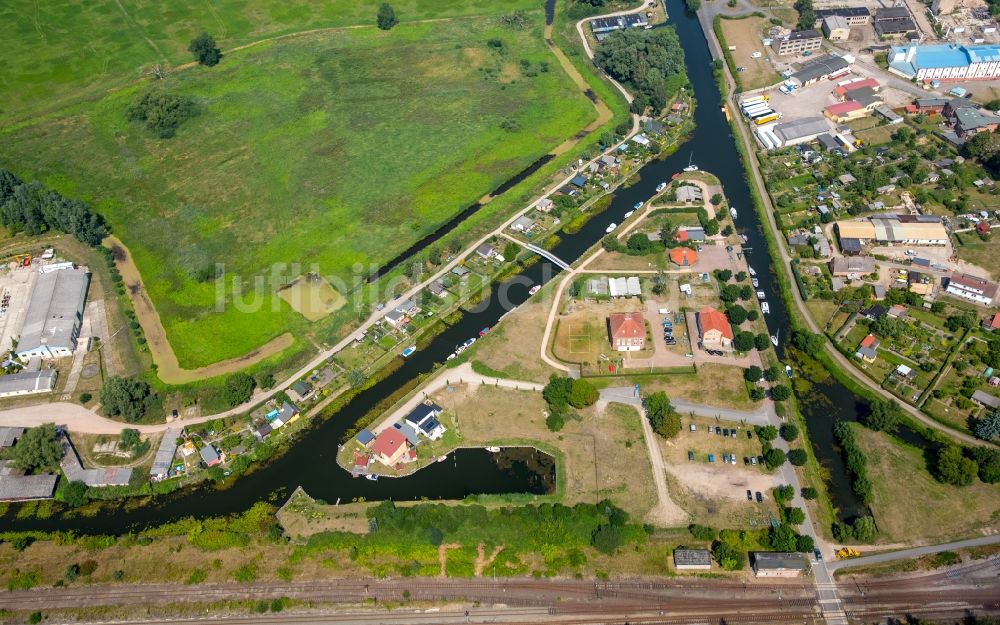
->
<box><xmin>0</xmin><ymin>0</ymin><xmax>538</xmax><ymax>121</ymax></box>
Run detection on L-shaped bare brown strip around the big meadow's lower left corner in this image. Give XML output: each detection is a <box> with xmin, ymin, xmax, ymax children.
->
<box><xmin>102</xmin><ymin>236</ymin><xmax>295</xmax><ymax>384</ymax></box>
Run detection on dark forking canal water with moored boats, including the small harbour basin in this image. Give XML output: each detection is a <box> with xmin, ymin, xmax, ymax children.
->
<box><xmin>0</xmin><ymin>0</ymin><xmax>880</xmax><ymax>533</ymax></box>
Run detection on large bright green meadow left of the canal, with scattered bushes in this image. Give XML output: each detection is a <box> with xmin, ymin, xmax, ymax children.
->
<box><xmin>0</xmin><ymin>11</ymin><xmax>595</xmax><ymax>369</ymax></box>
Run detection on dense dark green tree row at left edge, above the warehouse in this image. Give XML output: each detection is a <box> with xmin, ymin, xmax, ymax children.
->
<box><xmin>0</xmin><ymin>169</ymin><xmax>108</xmax><ymax>247</ymax></box>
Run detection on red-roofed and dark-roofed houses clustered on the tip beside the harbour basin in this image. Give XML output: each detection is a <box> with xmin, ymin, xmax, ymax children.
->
<box><xmin>354</xmin><ymin>402</ymin><xmax>447</xmax><ymax>473</ymax></box>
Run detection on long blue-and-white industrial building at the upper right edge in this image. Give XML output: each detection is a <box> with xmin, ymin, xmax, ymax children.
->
<box><xmin>889</xmin><ymin>44</ymin><xmax>1000</xmax><ymax>81</ymax></box>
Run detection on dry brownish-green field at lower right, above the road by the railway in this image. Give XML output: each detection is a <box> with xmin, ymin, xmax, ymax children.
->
<box><xmin>855</xmin><ymin>426</ymin><xmax>1000</xmax><ymax>544</ymax></box>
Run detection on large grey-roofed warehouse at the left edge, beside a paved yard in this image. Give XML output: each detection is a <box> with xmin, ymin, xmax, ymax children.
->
<box><xmin>17</xmin><ymin>267</ymin><xmax>90</xmax><ymax>361</ymax></box>
